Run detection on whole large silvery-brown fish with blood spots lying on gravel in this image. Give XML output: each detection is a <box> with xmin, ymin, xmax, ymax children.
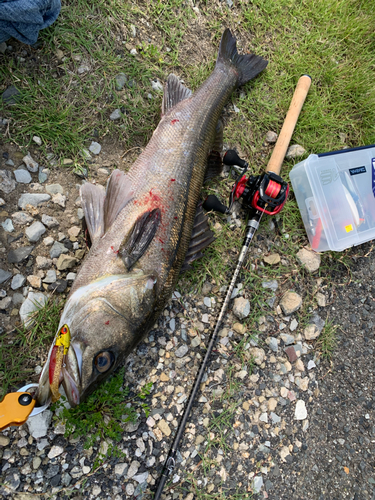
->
<box><xmin>37</xmin><ymin>29</ymin><xmax>268</xmax><ymax>406</ymax></box>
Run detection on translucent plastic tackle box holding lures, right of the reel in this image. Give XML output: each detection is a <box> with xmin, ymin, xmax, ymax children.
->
<box><xmin>289</xmin><ymin>144</ymin><xmax>375</xmax><ymax>252</ymax></box>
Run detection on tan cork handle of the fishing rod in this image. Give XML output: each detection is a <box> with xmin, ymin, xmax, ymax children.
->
<box><xmin>266</xmin><ymin>75</ymin><xmax>311</xmax><ymax>175</ymax></box>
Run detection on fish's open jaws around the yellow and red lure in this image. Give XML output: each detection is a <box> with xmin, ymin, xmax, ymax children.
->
<box><xmin>37</xmin><ymin>342</ymin><xmax>82</xmax><ymax>407</ymax></box>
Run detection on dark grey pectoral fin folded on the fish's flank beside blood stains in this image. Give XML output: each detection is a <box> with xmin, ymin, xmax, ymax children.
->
<box><xmin>119</xmin><ymin>208</ymin><xmax>161</xmax><ymax>271</ymax></box>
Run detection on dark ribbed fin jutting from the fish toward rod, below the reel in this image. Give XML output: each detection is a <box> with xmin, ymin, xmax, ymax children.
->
<box><xmin>181</xmin><ymin>202</ymin><xmax>215</xmax><ymax>272</ymax></box>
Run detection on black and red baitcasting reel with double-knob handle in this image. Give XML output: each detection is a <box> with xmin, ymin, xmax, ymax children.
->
<box><xmin>203</xmin><ymin>149</ymin><xmax>289</xmax><ymax>215</ymax></box>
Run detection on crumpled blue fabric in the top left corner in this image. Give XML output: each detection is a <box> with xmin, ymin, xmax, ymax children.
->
<box><xmin>0</xmin><ymin>0</ymin><xmax>61</xmax><ymax>45</ymax></box>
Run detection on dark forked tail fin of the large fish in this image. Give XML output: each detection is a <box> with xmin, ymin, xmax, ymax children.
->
<box><xmin>216</xmin><ymin>28</ymin><xmax>268</xmax><ymax>85</ymax></box>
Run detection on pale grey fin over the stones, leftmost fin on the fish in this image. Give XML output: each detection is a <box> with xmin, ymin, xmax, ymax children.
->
<box><xmin>80</xmin><ymin>182</ymin><xmax>105</xmax><ymax>244</ymax></box>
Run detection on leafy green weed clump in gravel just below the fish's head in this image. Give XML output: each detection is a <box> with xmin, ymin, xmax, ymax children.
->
<box><xmin>52</xmin><ymin>368</ymin><xmax>152</xmax><ymax>468</ymax></box>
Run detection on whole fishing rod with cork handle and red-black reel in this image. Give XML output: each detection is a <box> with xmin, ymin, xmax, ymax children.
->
<box><xmin>154</xmin><ymin>75</ymin><xmax>311</xmax><ymax>500</ymax></box>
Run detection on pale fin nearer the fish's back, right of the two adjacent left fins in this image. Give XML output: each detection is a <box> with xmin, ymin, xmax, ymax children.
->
<box><xmin>104</xmin><ymin>170</ymin><xmax>133</xmax><ymax>232</ymax></box>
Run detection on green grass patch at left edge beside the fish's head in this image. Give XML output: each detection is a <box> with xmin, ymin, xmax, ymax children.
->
<box><xmin>0</xmin><ymin>299</ymin><xmax>63</xmax><ymax>397</ymax></box>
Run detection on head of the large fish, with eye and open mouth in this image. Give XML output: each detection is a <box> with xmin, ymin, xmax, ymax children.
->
<box><xmin>37</xmin><ymin>270</ymin><xmax>156</xmax><ymax>406</ymax></box>
